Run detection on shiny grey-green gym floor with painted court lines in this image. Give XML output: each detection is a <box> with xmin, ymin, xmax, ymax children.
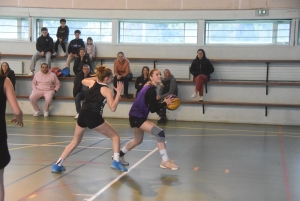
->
<box><xmin>4</xmin><ymin>115</ymin><xmax>300</xmax><ymax>201</ymax></box>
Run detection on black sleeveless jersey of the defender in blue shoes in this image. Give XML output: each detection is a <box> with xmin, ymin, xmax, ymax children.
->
<box><xmin>81</xmin><ymin>81</ymin><xmax>108</xmax><ymax>115</ymax></box>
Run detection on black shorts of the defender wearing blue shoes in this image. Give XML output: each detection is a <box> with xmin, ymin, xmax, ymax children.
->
<box><xmin>77</xmin><ymin>110</ymin><xmax>104</xmax><ymax>129</ymax></box>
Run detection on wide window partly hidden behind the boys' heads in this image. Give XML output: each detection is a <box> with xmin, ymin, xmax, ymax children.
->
<box><xmin>36</xmin><ymin>19</ymin><xmax>112</xmax><ymax>43</ymax></box>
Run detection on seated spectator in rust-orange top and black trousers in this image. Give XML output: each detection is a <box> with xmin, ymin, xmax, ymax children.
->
<box><xmin>114</xmin><ymin>52</ymin><xmax>132</xmax><ymax>98</ymax></box>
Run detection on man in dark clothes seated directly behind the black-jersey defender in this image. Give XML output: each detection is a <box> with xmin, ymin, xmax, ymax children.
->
<box><xmin>73</xmin><ymin>64</ymin><xmax>91</xmax><ymax>119</ymax></box>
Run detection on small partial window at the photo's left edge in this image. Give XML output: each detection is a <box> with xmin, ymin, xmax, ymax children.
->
<box><xmin>0</xmin><ymin>18</ymin><xmax>29</xmax><ymax>40</ymax></box>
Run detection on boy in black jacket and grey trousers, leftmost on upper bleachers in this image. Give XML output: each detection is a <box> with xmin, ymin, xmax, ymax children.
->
<box><xmin>29</xmin><ymin>27</ymin><xmax>53</xmax><ymax>75</ymax></box>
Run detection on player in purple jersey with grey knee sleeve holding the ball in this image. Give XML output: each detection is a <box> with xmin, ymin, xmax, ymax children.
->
<box><xmin>120</xmin><ymin>69</ymin><xmax>179</xmax><ymax>170</ymax></box>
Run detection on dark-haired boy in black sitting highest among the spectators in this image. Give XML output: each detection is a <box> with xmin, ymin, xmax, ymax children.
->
<box><xmin>53</xmin><ymin>19</ymin><xmax>69</xmax><ymax>56</ymax></box>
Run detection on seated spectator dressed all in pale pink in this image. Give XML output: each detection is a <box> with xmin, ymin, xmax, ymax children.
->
<box><xmin>29</xmin><ymin>63</ymin><xmax>60</xmax><ymax>117</ymax></box>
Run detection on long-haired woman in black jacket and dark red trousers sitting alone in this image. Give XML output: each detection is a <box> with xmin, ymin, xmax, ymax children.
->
<box><xmin>190</xmin><ymin>49</ymin><xmax>214</xmax><ymax>101</ymax></box>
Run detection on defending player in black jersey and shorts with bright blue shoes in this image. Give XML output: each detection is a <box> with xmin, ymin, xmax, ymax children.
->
<box><xmin>52</xmin><ymin>66</ymin><xmax>127</xmax><ymax>173</ymax></box>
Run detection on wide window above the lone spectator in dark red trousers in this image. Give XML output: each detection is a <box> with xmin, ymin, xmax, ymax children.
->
<box><xmin>205</xmin><ymin>20</ymin><xmax>291</xmax><ymax>45</ymax></box>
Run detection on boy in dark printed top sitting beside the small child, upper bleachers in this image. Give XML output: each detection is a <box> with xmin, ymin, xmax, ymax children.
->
<box><xmin>66</xmin><ymin>30</ymin><xmax>85</xmax><ymax>68</ymax></box>
